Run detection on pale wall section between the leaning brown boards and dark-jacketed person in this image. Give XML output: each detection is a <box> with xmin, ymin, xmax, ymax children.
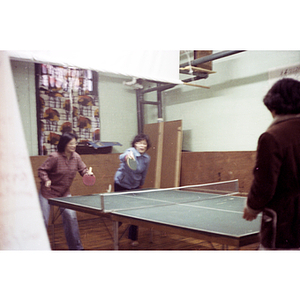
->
<box><xmin>159</xmin><ymin>51</ymin><xmax>300</xmax><ymax>151</ymax></box>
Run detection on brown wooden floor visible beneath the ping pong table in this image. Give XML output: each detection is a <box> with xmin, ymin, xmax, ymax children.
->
<box><xmin>48</xmin><ymin>218</ymin><xmax>258</xmax><ymax>250</ymax></box>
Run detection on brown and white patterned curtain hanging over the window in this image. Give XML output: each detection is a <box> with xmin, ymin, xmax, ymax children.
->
<box><xmin>37</xmin><ymin>64</ymin><xmax>100</xmax><ymax>155</ymax></box>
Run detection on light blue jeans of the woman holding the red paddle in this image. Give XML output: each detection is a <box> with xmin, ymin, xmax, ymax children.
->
<box><xmin>39</xmin><ymin>193</ymin><xmax>83</xmax><ymax>250</ymax></box>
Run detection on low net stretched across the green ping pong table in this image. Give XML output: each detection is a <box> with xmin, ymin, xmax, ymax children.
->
<box><xmin>101</xmin><ymin>180</ymin><xmax>239</xmax><ymax>211</ymax></box>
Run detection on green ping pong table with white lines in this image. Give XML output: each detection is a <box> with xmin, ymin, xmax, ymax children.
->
<box><xmin>49</xmin><ymin>182</ymin><xmax>261</xmax><ymax>250</ymax></box>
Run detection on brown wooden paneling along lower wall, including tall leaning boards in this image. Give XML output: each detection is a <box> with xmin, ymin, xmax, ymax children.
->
<box><xmin>30</xmin><ymin>148</ymin><xmax>256</xmax><ymax>225</ymax></box>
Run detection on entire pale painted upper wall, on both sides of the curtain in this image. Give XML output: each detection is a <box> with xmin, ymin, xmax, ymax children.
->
<box><xmin>12</xmin><ymin>51</ymin><xmax>300</xmax><ymax>155</ymax></box>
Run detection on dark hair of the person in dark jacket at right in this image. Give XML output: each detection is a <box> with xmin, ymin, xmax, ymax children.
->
<box><xmin>263</xmin><ymin>78</ymin><xmax>300</xmax><ymax>115</ymax></box>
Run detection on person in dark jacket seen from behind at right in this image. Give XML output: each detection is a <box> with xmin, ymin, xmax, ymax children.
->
<box><xmin>243</xmin><ymin>78</ymin><xmax>300</xmax><ymax>249</ymax></box>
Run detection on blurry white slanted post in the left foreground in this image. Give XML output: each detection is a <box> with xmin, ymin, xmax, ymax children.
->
<box><xmin>0</xmin><ymin>51</ymin><xmax>51</xmax><ymax>250</ymax></box>
